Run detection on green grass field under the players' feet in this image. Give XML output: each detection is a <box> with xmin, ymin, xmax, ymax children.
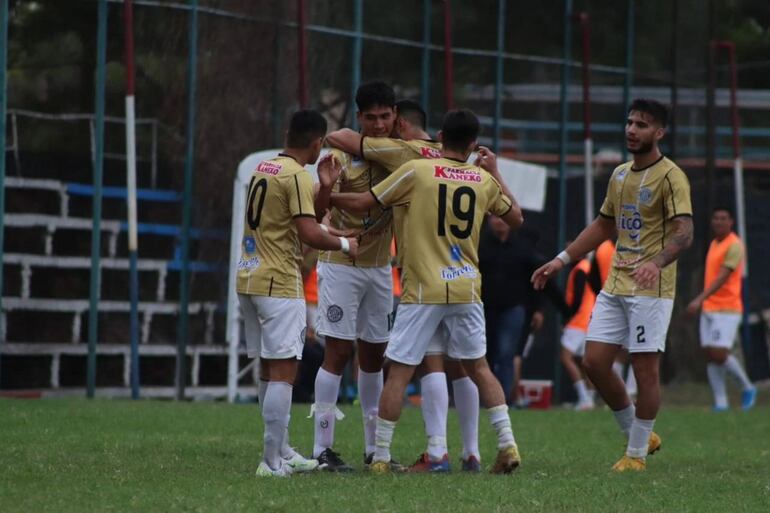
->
<box><xmin>0</xmin><ymin>388</ymin><xmax>770</xmax><ymax>513</ymax></box>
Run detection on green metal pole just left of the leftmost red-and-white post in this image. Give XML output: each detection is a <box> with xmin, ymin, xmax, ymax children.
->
<box><xmin>86</xmin><ymin>0</ymin><xmax>107</xmax><ymax>398</ymax></box>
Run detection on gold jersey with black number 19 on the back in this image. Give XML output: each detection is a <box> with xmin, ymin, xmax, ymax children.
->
<box><xmin>372</xmin><ymin>158</ymin><xmax>511</xmax><ymax>304</ymax></box>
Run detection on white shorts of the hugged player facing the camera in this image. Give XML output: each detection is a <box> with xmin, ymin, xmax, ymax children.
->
<box><xmin>315</xmin><ymin>262</ymin><xmax>393</xmax><ymax>343</ymax></box>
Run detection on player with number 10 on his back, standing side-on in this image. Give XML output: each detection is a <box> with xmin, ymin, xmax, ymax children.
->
<box><xmin>237</xmin><ymin>110</ymin><xmax>358</xmax><ymax>476</ymax></box>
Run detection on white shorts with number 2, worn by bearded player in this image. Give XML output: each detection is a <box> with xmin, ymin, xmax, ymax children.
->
<box><xmin>586</xmin><ymin>291</ymin><xmax>674</xmax><ymax>353</ymax></box>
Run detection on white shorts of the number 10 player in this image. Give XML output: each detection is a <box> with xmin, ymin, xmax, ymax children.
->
<box><xmin>238</xmin><ymin>294</ymin><xmax>307</xmax><ymax>360</ymax></box>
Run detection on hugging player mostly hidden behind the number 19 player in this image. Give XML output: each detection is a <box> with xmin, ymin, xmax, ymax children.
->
<box><xmin>327</xmin><ymin>100</ymin><xmax>481</xmax><ymax>472</ymax></box>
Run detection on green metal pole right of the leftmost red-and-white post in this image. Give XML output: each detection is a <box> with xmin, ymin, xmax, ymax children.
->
<box><xmin>176</xmin><ymin>0</ymin><xmax>198</xmax><ymax>401</ymax></box>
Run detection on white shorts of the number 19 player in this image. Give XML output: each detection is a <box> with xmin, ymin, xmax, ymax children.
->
<box><xmin>385</xmin><ymin>303</ymin><xmax>487</xmax><ymax>365</ymax></box>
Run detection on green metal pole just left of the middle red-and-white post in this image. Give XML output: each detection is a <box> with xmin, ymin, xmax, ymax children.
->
<box><xmin>553</xmin><ymin>0</ymin><xmax>572</xmax><ymax>398</ymax></box>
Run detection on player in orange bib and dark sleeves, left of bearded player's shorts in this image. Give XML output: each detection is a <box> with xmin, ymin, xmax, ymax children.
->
<box><xmin>561</xmin><ymin>254</ymin><xmax>596</xmax><ymax>411</ymax></box>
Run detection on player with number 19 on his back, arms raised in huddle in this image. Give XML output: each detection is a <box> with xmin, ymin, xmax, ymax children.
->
<box><xmin>333</xmin><ymin>110</ymin><xmax>522</xmax><ymax>473</ymax></box>
